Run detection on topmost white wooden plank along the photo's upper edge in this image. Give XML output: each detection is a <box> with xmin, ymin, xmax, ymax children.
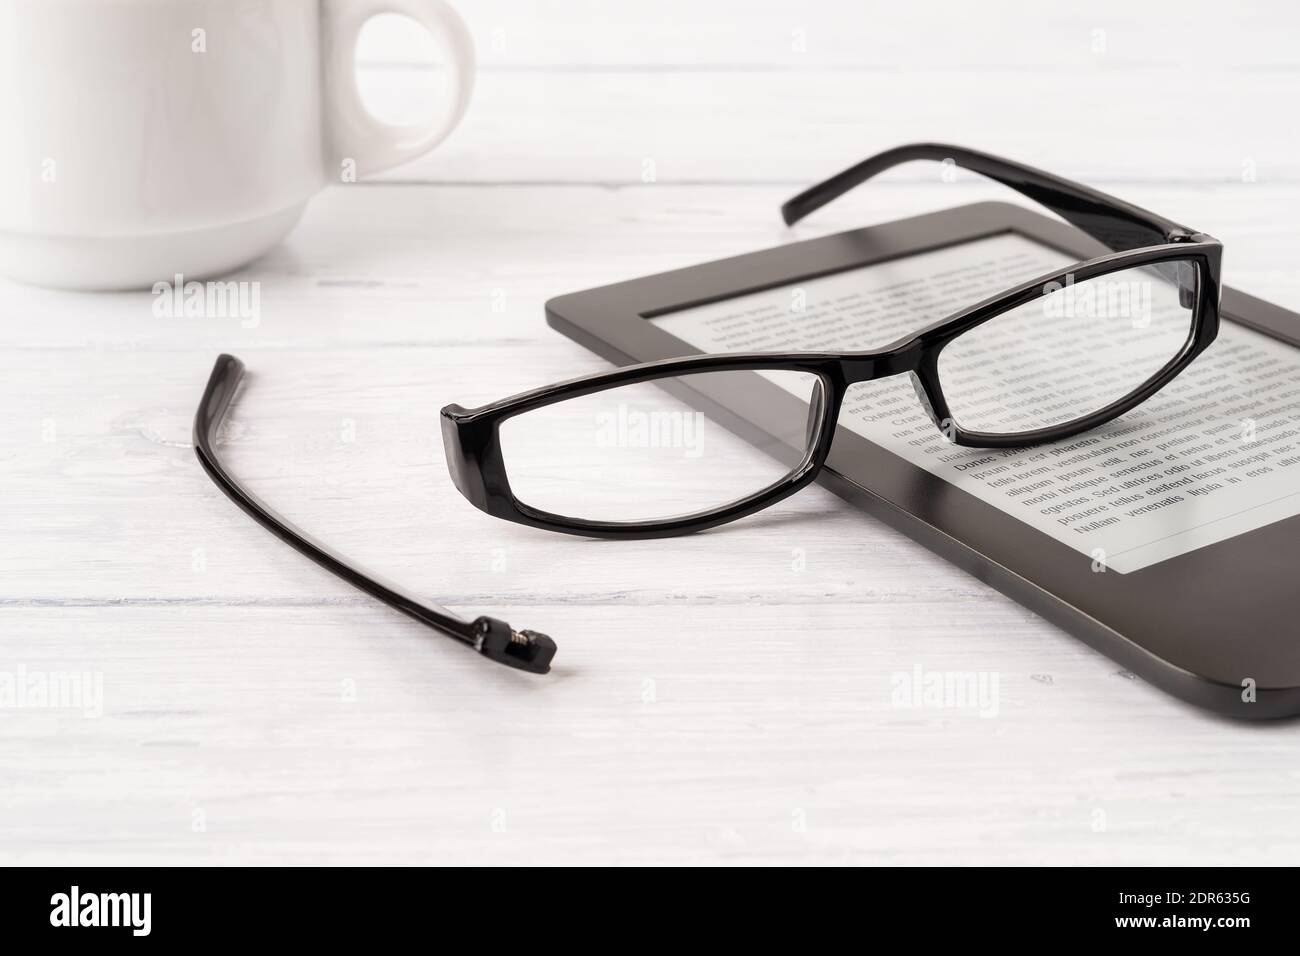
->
<box><xmin>358</xmin><ymin>0</ymin><xmax>1300</xmax><ymax>75</ymax></box>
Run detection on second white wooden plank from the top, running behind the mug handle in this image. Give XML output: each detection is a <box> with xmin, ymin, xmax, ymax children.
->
<box><xmin>361</xmin><ymin>68</ymin><xmax>1300</xmax><ymax>186</ymax></box>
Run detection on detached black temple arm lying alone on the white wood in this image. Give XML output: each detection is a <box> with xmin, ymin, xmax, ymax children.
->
<box><xmin>194</xmin><ymin>355</ymin><xmax>555</xmax><ymax>674</ymax></box>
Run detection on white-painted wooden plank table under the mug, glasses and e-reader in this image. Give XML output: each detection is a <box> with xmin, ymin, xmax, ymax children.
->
<box><xmin>0</xmin><ymin>0</ymin><xmax>1300</xmax><ymax>864</ymax></box>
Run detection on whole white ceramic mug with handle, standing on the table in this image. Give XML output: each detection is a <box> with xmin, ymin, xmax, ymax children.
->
<box><xmin>0</xmin><ymin>0</ymin><xmax>473</xmax><ymax>289</ymax></box>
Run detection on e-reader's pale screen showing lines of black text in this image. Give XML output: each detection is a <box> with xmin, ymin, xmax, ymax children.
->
<box><xmin>647</xmin><ymin>232</ymin><xmax>1300</xmax><ymax>574</ymax></box>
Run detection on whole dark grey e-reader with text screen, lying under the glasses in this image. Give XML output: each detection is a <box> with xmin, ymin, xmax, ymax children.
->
<box><xmin>546</xmin><ymin>203</ymin><xmax>1300</xmax><ymax>718</ymax></box>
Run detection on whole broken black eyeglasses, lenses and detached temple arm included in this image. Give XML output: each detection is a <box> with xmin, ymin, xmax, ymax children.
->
<box><xmin>194</xmin><ymin>143</ymin><xmax>1223</xmax><ymax>672</ymax></box>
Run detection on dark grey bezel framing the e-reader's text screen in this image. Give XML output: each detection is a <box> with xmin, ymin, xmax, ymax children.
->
<box><xmin>546</xmin><ymin>203</ymin><xmax>1300</xmax><ymax>718</ymax></box>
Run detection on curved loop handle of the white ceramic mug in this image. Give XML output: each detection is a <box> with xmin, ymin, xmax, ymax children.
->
<box><xmin>321</xmin><ymin>0</ymin><xmax>475</xmax><ymax>176</ymax></box>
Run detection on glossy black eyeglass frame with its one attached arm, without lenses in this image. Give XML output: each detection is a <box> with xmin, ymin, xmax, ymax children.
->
<box><xmin>442</xmin><ymin>143</ymin><xmax>1223</xmax><ymax>538</ymax></box>
